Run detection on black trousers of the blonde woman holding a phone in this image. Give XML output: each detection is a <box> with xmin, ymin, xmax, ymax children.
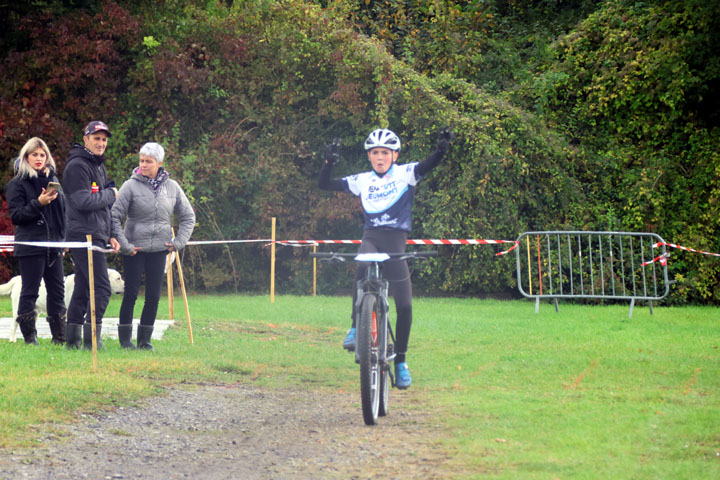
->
<box><xmin>16</xmin><ymin>250</ymin><xmax>65</xmax><ymax>317</ymax></box>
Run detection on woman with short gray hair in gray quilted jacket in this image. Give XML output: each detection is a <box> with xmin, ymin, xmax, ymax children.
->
<box><xmin>112</xmin><ymin>142</ymin><xmax>195</xmax><ymax>350</ymax></box>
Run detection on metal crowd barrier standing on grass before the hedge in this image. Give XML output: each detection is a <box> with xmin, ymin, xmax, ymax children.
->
<box><xmin>515</xmin><ymin>231</ymin><xmax>675</xmax><ymax>317</ymax></box>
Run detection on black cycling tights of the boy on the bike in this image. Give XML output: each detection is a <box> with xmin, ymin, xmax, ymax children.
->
<box><xmin>352</xmin><ymin>228</ymin><xmax>412</xmax><ymax>363</ymax></box>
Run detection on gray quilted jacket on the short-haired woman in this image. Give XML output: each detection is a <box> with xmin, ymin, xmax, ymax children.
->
<box><xmin>112</xmin><ymin>169</ymin><xmax>195</xmax><ymax>254</ymax></box>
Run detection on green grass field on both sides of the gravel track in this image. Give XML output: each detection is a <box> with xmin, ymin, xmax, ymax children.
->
<box><xmin>0</xmin><ymin>296</ymin><xmax>720</xmax><ymax>479</ymax></box>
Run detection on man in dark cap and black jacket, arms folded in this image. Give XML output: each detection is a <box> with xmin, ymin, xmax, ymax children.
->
<box><xmin>63</xmin><ymin>121</ymin><xmax>120</xmax><ymax>349</ymax></box>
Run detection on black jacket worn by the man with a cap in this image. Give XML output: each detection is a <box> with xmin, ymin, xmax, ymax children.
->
<box><xmin>63</xmin><ymin>143</ymin><xmax>115</xmax><ymax>245</ymax></box>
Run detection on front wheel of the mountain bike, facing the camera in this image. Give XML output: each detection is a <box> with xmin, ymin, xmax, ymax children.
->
<box><xmin>355</xmin><ymin>295</ymin><xmax>381</xmax><ymax>425</ymax></box>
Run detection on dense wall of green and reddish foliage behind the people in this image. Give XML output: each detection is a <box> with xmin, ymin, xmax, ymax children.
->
<box><xmin>0</xmin><ymin>0</ymin><xmax>720</xmax><ymax>302</ymax></box>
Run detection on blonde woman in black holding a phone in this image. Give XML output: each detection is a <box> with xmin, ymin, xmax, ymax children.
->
<box><xmin>5</xmin><ymin>137</ymin><xmax>66</xmax><ymax>345</ymax></box>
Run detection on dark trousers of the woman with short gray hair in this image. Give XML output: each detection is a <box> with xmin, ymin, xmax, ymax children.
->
<box><xmin>120</xmin><ymin>250</ymin><xmax>168</xmax><ymax>325</ymax></box>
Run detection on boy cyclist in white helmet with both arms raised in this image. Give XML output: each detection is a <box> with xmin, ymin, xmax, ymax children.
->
<box><xmin>318</xmin><ymin>129</ymin><xmax>454</xmax><ymax>389</ymax></box>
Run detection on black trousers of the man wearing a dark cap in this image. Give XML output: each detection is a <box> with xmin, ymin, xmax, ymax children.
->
<box><xmin>67</xmin><ymin>248</ymin><xmax>112</xmax><ymax>325</ymax></box>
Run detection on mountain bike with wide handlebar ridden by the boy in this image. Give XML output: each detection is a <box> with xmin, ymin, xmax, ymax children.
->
<box><xmin>310</xmin><ymin>251</ymin><xmax>437</xmax><ymax>425</ymax></box>
